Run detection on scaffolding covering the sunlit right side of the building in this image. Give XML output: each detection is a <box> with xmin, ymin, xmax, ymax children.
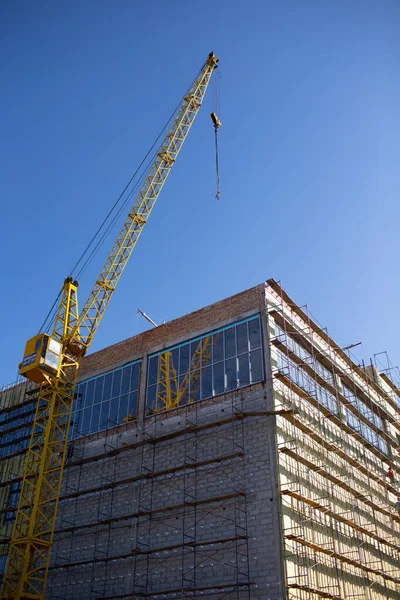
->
<box><xmin>268</xmin><ymin>281</ymin><xmax>400</xmax><ymax>600</ymax></box>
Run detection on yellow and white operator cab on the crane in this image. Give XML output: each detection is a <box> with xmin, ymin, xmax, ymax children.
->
<box><xmin>19</xmin><ymin>333</ymin><xmax>61</xmax><ymax>383</ymax></box>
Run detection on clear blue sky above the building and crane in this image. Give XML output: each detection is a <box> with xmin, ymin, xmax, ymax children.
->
<box><xmin>0</xmin><ymin>0</ymin><xmax>400</xmax><ymax>383</ymax></box>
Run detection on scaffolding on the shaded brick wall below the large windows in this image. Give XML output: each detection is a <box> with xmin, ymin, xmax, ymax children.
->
<box><xmin>43</xmin><ymin>385</ymin><xmax>282</xmax><ymax>600</ymax></box>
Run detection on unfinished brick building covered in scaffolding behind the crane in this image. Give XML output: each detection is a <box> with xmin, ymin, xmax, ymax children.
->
<box><xmin>0</xmin><ymin>280</ymin><xmax>400</xmax><ymax>600</ymax></box>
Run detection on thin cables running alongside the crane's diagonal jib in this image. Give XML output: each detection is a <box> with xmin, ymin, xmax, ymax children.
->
<box><xmin>39</xmin><ymin>65</ymin><xmax>204</xmax><ymax>332</ymax></box>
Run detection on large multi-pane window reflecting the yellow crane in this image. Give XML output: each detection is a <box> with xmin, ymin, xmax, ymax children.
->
<box><xmin>146</xmin><ymin>315</ymin><xmax>264</xmax><ymax>411</ymax></box>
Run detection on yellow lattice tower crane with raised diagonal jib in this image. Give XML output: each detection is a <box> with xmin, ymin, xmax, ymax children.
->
<box><xmin>0</xmin><ymin>52</ymin><xmax>218</xmax><ymax>600</ymax></box>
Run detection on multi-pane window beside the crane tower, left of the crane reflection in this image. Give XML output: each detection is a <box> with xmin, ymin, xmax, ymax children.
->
<box><xmin>71</xmin><ymin>361</ymin><xmax>140</xmax><ymax>439</ymax></box>
